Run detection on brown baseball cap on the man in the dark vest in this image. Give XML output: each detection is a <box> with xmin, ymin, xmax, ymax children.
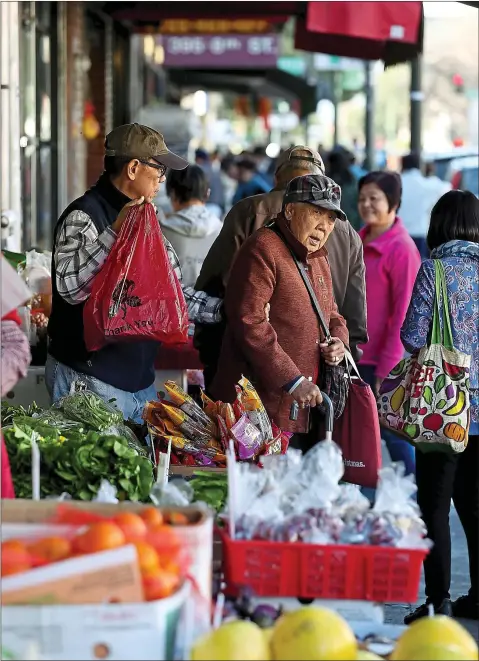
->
<box><xmin>105</xmin><ymin>124</ymin><xmax>188</xmax><ymax>170</ymax></box>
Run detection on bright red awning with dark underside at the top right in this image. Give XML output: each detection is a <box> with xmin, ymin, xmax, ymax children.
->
<box><xmin>295</xmin><ymin>1</ymin><xmax>424</xmax><ymax>66</ymax></box>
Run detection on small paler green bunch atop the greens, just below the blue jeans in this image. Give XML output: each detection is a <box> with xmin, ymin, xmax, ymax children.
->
<box><xmin>58</xmin><ymin>390</ymin><xmax>123</xmax><ymax>431</ymax></box>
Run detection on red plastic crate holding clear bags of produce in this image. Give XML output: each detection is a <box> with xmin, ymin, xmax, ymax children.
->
<box><xmin>221</xmin><ymin>531</ymin><xmax>427</xmax><ymax>603</ymax></box>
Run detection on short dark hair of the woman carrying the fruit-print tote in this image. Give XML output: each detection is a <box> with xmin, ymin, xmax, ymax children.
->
<box><xmin>427</xmin><ymin>190</ymin><xmax>479</xmax><ymax>250</ymax></box>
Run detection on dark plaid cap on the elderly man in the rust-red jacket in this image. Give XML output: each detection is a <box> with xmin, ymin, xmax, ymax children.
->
<box><xmin>283</xmin><ymin>174</ymin><xmax>348</xmax><ymax>220</ymax></box>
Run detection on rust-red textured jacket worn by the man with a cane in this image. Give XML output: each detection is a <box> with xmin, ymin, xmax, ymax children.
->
<box><xmin>210</xmin><ymin>218</ymin><xmax>349</xmax><ymax>433</ymax></box>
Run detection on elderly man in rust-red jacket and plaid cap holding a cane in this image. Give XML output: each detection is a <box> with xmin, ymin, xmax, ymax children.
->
<box><xmin>210</xmin><ymin>175</ymin><xmax>349</xmax><ymax>451</ymax></box>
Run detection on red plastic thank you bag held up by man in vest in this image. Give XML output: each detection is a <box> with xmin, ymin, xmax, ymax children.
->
<box><xmin>83</xmin><ymin>204</ymin><xmax>188</xmax><ymax>351</ymax></box>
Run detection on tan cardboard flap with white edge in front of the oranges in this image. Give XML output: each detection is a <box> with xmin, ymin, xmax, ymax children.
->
<box><xmin>1</xmin><ymin>545</ymin><xmax>144</xmax><ymax>606</ymax></box>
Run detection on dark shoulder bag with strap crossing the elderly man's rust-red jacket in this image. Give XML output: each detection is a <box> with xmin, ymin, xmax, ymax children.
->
<box><xmin>266</xmin><ymin>223</ymin><xmax>350</xmax><ymax>420</ymax></box>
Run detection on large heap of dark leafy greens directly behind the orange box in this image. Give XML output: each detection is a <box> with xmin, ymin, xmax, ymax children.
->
<box><xmin>4</xmin><ymin>417</ymin><xmax>153</xmax><ymax>502</ymax></box>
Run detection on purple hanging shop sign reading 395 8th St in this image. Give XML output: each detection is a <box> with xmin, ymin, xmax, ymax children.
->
<box><xmin>161</xmin><ymin>34</ymin><xmax>279</xmax><ymax>69</ymax></box>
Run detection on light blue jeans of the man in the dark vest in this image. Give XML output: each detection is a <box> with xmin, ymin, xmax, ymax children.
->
<box><xmin>45</xmin><ymin>355</ymin><xmax>157</xmax><ymax>425</ymax></box>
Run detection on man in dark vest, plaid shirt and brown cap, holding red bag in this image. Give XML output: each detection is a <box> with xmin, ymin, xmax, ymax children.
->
<box><xmin>46</xmin><ymin>124</ymin><xmax>222</xmax><ymax>422</ymax></box>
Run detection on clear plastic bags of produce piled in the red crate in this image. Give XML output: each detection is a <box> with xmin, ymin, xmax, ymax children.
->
<box><xmin>224</xmin><ymin>441</ymin><xmax>430</xmax><ymax>549</ymax></box>
